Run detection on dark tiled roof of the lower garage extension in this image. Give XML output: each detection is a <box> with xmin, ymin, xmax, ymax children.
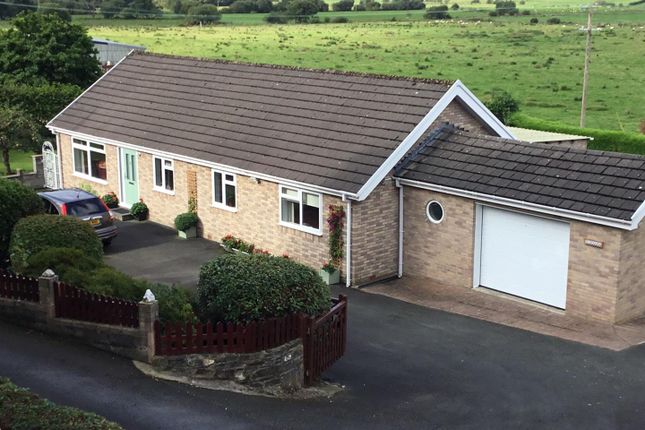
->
<box><xmin>396</xmin><ymin>126</ymin><xmax>645</xmax><ymax>220</ymax></box>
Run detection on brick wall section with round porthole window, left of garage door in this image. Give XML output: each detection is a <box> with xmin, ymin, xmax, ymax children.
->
<box><xmin>403</xmin><ymin>187</ymin><xmax>475</xmax><ymax>288</ymax></box>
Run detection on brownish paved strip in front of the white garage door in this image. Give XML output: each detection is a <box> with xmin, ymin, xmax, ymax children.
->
<box><xmin>362</xmin><ymin>276</ymin><xmax>645</xmax><ymax>351</ymax></box>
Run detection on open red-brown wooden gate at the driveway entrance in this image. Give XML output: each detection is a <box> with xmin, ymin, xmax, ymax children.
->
<box><xmin>302</xmin><ymin>294</ymin><xmax>347</xmax><ymax>385</ymax></box>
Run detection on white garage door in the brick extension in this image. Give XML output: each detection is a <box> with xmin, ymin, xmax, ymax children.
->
<box><xmin>479</xmin><ymin>206</ymin><xmax>569</xmax><ymax>309</ymax></box>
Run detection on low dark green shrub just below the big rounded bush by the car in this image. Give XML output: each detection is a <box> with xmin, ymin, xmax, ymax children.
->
<box><xmin>22</xmin><ymin>248</ymin><xmax>102</xmax><ymax>288</ymax></box>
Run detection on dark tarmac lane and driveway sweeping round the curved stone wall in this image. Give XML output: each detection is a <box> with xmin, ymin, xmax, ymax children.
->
<box><xmin>0</xmin><ymin>288</ymin><xmax>645</xmax><ymax>430</ymax></box>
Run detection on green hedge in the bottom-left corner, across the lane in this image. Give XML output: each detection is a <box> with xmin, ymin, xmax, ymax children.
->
<box><xmin>0</xmin><ymin>378</ymin><xmax>123</xmax><ymax>430</ymax></box>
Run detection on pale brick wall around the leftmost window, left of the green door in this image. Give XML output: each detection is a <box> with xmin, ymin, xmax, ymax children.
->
<box><xmin>58</xmin><ymin>134</ymin><xmax>120</xmax><ymax>195</ymax></box>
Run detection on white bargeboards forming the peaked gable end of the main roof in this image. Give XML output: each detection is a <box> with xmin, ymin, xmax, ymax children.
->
<box><xmin>358</xmin><ymin>81</ymin><xmax>517</xmax><ymax>201</ymax></box>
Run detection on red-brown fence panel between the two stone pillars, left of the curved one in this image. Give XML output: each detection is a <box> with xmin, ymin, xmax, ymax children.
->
<box><xmin>54</xmin><ymin>282</ymin><xmax>139</xmax><ymax>327</ymax></box>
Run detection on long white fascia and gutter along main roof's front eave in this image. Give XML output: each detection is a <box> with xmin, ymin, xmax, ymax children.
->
<box><xmin>49</xmin><ymin>127</ymin><xmax>357</xmax><ymax>200</ymax></box>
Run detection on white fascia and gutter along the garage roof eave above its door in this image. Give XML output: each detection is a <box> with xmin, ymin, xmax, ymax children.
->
<box><xmin>397</xmin><ymin>178</ymin><xmax>638</xmax><ymax>230</ymax></box>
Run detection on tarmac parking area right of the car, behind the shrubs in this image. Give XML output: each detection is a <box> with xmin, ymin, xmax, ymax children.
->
<box><xmin>105</xmin><ymin>221</ymin><xmax>224</xmax><ymax>287</ymax></box>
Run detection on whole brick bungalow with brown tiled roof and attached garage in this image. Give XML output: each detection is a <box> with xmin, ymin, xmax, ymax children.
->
<box><xmin>48</xmin><ymin>52</ymin><xmax>645</xmax><ymax>321</ymax></box>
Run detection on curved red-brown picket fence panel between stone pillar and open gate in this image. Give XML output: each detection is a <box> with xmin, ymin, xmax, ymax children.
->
<box><xmin>155</xmin><ymin>315</ymin><xmax>300</xmax><ymax>355</ymax></box>
